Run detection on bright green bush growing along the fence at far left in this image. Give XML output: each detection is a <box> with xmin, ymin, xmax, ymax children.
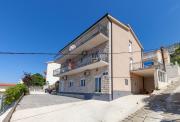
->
<box><xmin>5</xmin><ymin>84</ymin><xmax>28</xmax><ymax>105</ymax></box>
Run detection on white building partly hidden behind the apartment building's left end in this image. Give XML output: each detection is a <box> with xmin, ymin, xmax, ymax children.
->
<box><xmin>46</xmin><ymin>62</ymin><xmax>61</xmax><ymax>85</ymax></box>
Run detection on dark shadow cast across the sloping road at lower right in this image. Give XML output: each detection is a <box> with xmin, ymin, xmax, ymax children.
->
<box><xmin>144</xmin><ymin>93</ymin><xmax>180</xmax><ymax>122</ymax></box>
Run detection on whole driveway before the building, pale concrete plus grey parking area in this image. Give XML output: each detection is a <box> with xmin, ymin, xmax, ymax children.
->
<box><xmin>11</xmin><ymin>95</ymin><xmax>147</xmax><ymax>122</ymax></box>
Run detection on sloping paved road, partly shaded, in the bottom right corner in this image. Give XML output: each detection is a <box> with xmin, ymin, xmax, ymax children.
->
<box><xmin>123</xmin><ymin>81</ymin><xmax>180</xmax><ymax>122</ymax></box>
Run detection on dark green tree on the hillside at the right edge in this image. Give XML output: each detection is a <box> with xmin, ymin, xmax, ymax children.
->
<box><xmin>171</xmin><ymin>47</ymin><xmax>180</xmax><ymax>65</ymax></box>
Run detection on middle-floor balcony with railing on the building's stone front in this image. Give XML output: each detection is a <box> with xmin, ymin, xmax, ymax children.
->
<box><xmin>53</xmin><ymin>54</ymin><xmax>108</xmax><ymax>77</ymax></box>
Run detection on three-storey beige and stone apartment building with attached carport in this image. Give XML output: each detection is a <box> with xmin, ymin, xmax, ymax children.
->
<box><xmin>54</xmin><ymin>14</ymin><xmax>165</xmax><ymax>100</ymax></box>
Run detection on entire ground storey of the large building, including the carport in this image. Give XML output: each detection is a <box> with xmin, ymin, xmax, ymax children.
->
<box><xmin>59</xmin><ymin>66</ymin><xmax>167</xmax><ymax>101</ymax></box>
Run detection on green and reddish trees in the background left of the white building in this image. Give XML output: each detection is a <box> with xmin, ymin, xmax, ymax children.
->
<box><xmin>22</xmin><ymin>73</ymin><xmax>46</xmax><ymax>87</ymax></box>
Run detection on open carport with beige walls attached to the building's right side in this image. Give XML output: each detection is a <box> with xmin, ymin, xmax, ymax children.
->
<box><xmin>131</xmin><ymin>68</ymin><xmax>168</xmax><ymax>94</ymax></box>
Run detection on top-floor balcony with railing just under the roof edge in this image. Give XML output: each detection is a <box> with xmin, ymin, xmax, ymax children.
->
<box><xmin>56</xmin><ymin>24</ymin><xmax>109</xmax><ymax>63</ymax></box>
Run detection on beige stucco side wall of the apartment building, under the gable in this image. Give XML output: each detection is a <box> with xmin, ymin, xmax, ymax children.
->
<box><xmin>112</xmin><ymin>23</ymin><xmax>142</xmax><ymax>98</ymax></box>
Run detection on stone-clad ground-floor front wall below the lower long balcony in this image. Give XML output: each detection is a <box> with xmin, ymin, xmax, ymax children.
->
<box><xmin>59</xmin><ymin>66</ymin><xmax>111</xmax><ymax>100</ymax></box>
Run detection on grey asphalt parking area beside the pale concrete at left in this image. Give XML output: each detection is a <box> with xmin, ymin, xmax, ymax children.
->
<box><xmin>16</xmin><ymin>94</ymin><xmax>82</xmax><ymax>110</ymax></box>
